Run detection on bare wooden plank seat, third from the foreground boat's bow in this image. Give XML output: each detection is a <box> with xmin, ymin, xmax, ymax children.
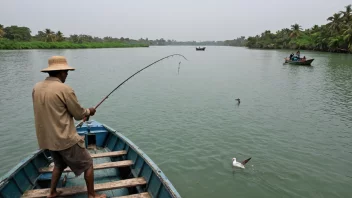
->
<box><xmin>22</xmin><ymin>177</ymin><xmax>147</xmax><ymax>198</ymax></box>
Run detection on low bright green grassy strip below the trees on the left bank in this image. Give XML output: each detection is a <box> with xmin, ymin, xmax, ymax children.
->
<box><xmin>0</xmin><ymin>39</ymin><xmax>149</xmax><ymax>50</ymax></box>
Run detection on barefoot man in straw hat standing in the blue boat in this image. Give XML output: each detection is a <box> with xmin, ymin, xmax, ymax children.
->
<box><xmin>32</xmin><ymin>56</ymin><xmax>106</xmax><ymax>198</ymax></box>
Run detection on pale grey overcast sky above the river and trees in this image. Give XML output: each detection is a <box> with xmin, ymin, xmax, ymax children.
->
<box><xmin>0</xmin><ymin>0</ymin><xmax>352</xmax><ymax>41</ymax></box>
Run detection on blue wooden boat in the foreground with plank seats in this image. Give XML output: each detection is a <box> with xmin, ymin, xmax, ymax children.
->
<box><xmin>0</xmin><ymin>121</ymin><xmax>181</xmax><ymax>198</ymax></box>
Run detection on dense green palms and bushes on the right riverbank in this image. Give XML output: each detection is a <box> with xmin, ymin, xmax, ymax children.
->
<box><xmin>246</xmin><ymin>5</ymin><xmax>352</xmax><ymax>53</ymax></box>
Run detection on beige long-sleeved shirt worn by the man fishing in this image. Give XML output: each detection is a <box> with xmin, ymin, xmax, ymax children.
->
<box><xmin>32</xmin><ymin>77</ymin><xmax>89</xmax><ymax>151</ymax></box>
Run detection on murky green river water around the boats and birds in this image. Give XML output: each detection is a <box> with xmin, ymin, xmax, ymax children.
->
<box><xmin>0</xmin><ymin>47</ymin><xmax>352</xmax><ymax>198</ymax></box>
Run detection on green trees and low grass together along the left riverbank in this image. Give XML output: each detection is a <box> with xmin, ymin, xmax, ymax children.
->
<box><xmin>0</xmin><ymin>24</ymin><xmax>149</xmax><ymax>49</ymax></box>
